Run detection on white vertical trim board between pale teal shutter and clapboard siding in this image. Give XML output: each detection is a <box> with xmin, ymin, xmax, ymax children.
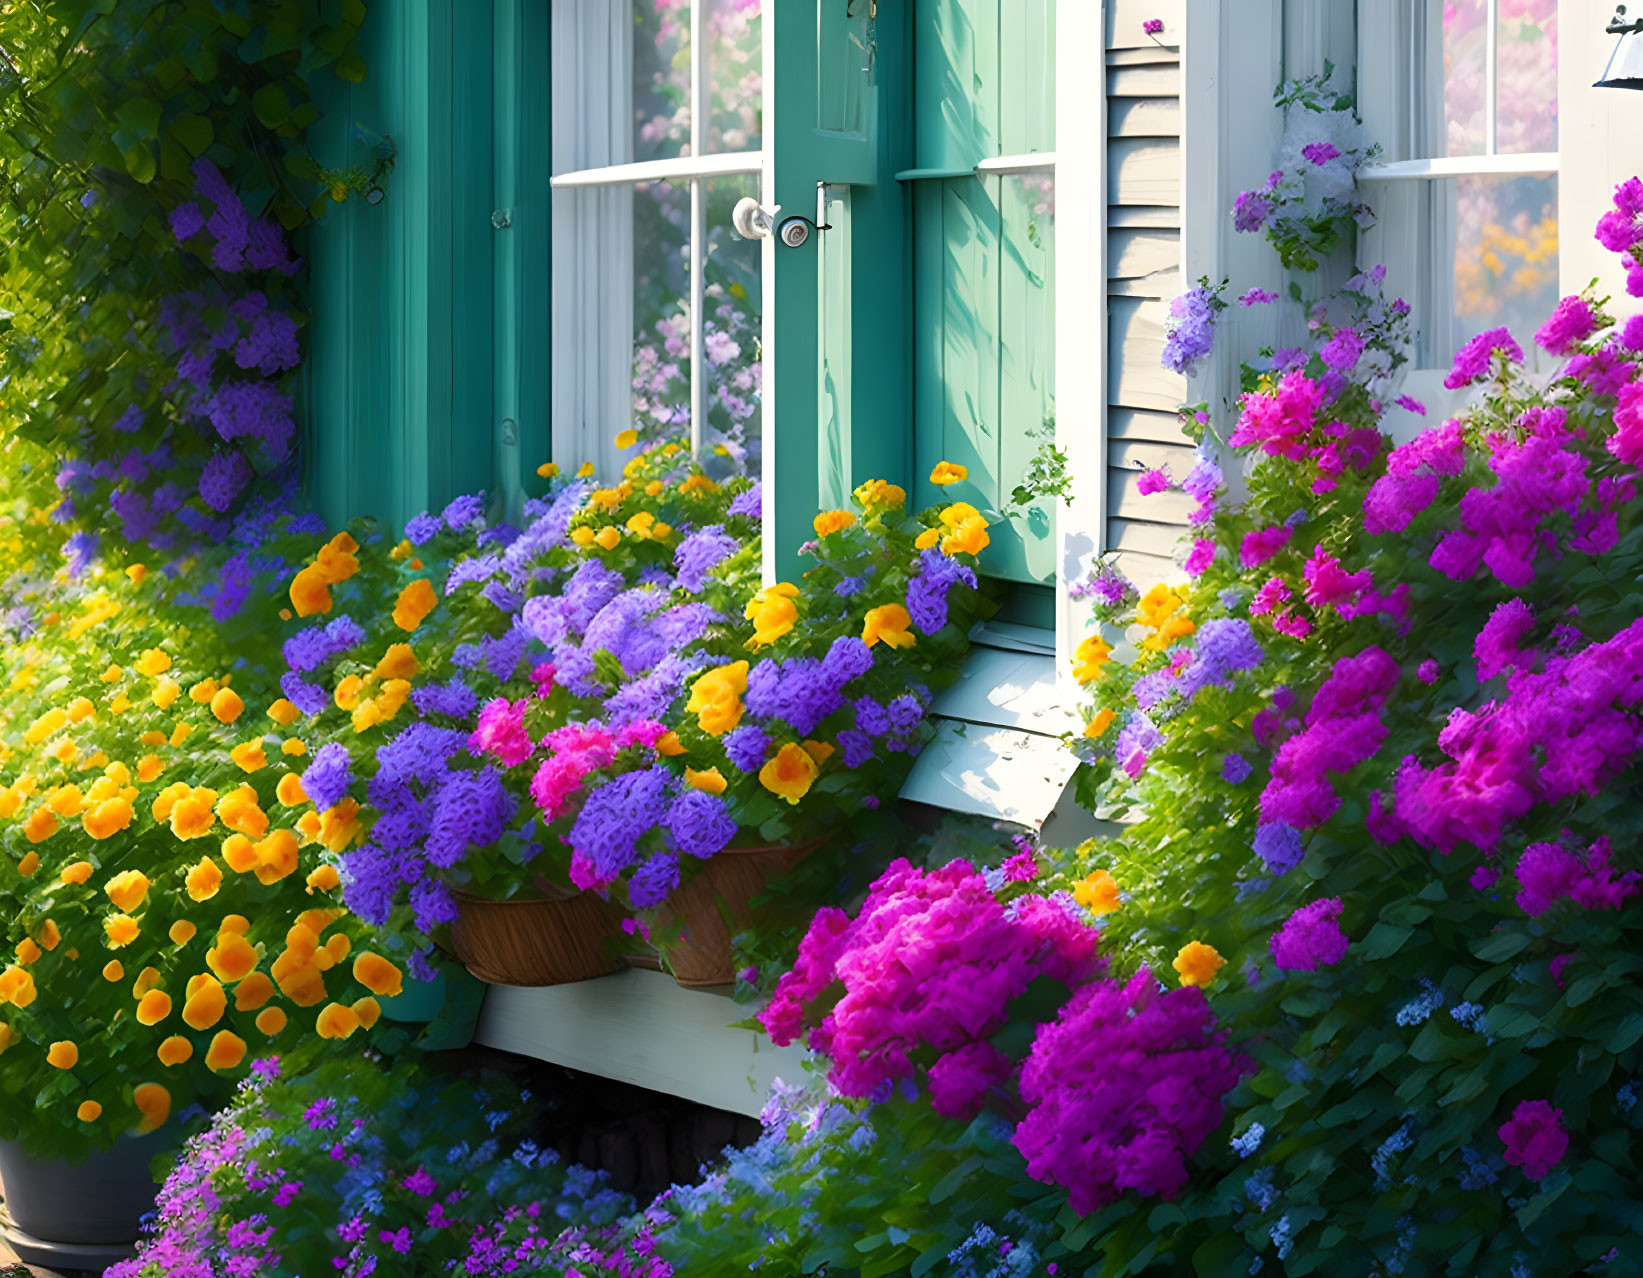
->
<box><xmin>1040</xmin><ymin>3</ymin><xmax>1107</xmax><ymax>686</ymax></box>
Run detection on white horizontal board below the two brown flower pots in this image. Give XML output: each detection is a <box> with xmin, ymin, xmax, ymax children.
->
<box><xmin>473</xmin><ymin>968</ymin><xmax>807</xmax><ymax>1117</ymax></box>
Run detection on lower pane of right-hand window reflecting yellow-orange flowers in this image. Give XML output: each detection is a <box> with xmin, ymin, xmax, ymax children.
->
<box><xmin>1452</xmin><ymin>177</ymin><xmax>1558</xmax><ymax>358</ymax></box>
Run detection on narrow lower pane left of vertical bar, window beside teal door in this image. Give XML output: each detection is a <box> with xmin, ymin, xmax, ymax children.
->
<box><xmin>633</xmin><ymin>182</ymin><xmax>690</xmax><ymax>442</ymax></box>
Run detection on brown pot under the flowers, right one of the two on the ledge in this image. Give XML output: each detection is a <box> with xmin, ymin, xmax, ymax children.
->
<box><xmin>656</xmin><ymin>839</ymin><xmax>814</xmax><ymax>989</ymax></box>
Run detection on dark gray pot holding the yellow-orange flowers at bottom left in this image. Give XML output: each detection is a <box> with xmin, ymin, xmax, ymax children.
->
<box><xmin>0</xmin><ymin>1132</ymin><xmax>176</xmax><ymax>1244</ymax></box>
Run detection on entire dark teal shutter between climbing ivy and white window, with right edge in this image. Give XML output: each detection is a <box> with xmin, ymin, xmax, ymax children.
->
<box><xmin>304</xmin><ymin>0</ymin><xmax>549</xmax><ymax>527</ymax></box>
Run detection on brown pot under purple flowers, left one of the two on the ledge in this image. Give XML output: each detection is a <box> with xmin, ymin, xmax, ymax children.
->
<box><xmin>450</xmin><ymin>892</ymin><xmax>623</xmax><ymax>986</ymax></box>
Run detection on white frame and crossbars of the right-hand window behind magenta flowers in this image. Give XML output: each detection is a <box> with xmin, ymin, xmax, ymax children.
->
<box><xmin>1357</xmin><ymin>0</ymin><xmax>1564</xmax><ymax>439</ymax></box>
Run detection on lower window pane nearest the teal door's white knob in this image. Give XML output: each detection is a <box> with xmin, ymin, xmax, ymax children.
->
<box><xmin>702</xmin><ymin>176</ymin><xmax>764</xmax><ymax>473</ymax></box>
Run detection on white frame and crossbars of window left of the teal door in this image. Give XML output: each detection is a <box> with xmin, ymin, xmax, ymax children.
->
<box><xmin>549</xmin><ymin>0</ymin><xmax>774</xmax><ymax>475</ymax></box>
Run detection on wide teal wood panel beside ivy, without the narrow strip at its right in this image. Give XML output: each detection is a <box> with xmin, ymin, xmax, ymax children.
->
<box><xmin>306</xmin><ymin>0</ymin><xmax>496</xmax><ymax>527</ymax></box>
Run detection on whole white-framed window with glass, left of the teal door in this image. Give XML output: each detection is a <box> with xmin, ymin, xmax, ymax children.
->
<box><xmin>552</xmin><ymin>0</ymin><xmax>764</xmax><ymax>473</ymax></box>
